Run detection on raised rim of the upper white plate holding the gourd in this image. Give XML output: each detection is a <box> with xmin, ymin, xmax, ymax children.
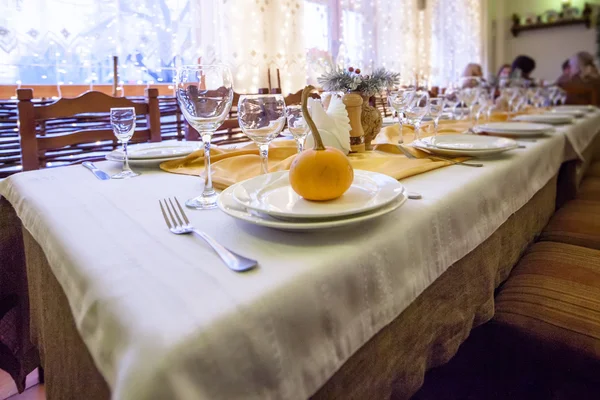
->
<box><xmin>232</xmin><ymin>169</ymin><xmax>406</xmax><ymax>220</ymax></box>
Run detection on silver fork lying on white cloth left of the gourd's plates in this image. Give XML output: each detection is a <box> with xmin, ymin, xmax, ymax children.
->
<box><xmin>158</xmin><ymin>197</ymin><xmax>258</xmax><ymax>272</ymax></box>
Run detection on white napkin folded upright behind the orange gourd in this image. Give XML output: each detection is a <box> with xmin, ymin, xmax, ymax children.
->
<box><xmin>304</xmin><ymin>96</ymin><xmax>350</xmax><ymax>154</ymax></box>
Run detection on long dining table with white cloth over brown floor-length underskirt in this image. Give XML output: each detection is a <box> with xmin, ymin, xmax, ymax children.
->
<box><xmin>0</xmin><ymin>110</ymin><xmax>600</xmax><ymax>400</ymax></box>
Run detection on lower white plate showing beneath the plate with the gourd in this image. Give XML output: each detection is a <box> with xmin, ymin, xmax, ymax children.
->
<box><xmin>217</xmin><ymin>183</ymin><xmax>407</xmax><ymax>232</ymax></box>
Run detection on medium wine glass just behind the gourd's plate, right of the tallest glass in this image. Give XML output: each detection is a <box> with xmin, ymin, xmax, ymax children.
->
<box><xmin>238</xmin><ymin>94</ymin><xmax>286</xmax><ymax>174</ymax></box>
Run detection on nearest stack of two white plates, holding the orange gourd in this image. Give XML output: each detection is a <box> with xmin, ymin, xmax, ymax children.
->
<box><xmin>217</xmin><ymin>170</ymin><xmax>407</xmax><ymax>231</ymax></box>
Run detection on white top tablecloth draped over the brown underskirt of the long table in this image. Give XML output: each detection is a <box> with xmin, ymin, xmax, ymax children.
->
<box><xmin>0</xmin><ymin>113</ymin><xmax>600</xmax><ymax>400</ymax></box>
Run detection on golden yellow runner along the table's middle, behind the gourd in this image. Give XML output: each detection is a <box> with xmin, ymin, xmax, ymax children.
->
<box><xmin>160</xmin><ymin>111</ymin><xmax>528</xmax><ymax>189</ymax></box>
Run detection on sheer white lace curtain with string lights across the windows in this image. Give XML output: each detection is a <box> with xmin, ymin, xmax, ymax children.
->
<box><xmin>0</xmin><ymin>0</ymin><xmax>482</xmax><ymax>93</ymax></box>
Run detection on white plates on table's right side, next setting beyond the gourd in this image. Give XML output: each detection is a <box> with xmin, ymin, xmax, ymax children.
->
<box><xmin>412</xmin><ymin>134</ymin><xmax>519</xmax><ymax>157</ymax></box>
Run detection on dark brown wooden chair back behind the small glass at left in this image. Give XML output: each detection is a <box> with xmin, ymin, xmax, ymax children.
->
<box><xmin>17</xmin><ymin>89</ymin><xmax>161</xmax><ymax>171</ymax></box>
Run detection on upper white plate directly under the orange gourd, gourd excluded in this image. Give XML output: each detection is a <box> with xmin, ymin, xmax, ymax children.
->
<box><xmin>233</xmin><ymin>170</ymin><xmax>404</xmax><ymax>219</ymax></box>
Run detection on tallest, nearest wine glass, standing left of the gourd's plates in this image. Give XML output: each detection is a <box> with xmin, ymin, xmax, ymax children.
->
<box><xmin>175</xmin><ymin>64</ymin><xmax>233</xmax><ymax>210</ymax></box>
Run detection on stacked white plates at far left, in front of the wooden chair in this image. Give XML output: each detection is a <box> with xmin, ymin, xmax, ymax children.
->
<box><xmin>106</xmin><ymin>141</ymin><xmax>196</xmax><ymax>166</ymax></box>
